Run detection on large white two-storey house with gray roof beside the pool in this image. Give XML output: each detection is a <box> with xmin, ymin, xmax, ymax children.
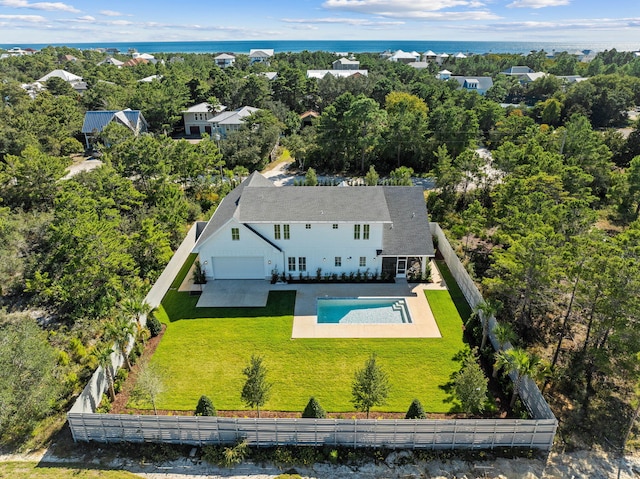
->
<box><xmin>193</xmin><ymin>172</ymin><xmax>435</xmax><ymax>280</ymax></box>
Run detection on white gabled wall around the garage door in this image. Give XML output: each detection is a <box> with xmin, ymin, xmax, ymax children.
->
<box><xmin>199</xmin><ymin>220</ymin><xmax>283</xmax><ymax>279</ymax></box>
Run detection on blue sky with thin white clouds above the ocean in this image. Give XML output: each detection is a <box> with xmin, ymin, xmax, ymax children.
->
<box><xmin>0</xmin><ymin>0</ymin><xmax>640</xmax><ymax>49</ymax></box>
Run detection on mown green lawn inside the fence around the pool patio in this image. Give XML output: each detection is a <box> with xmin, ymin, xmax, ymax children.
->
<box><xmin>152</xmin><ymin>280</ymin><xmax>466</xmax><ymax>417</ymax></box>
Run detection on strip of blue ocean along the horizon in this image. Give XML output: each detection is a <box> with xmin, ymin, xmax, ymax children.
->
<box><xmin>0</xmin><ymin>40</ymin><xmax>640</xmax><ymax>54</ymax></box>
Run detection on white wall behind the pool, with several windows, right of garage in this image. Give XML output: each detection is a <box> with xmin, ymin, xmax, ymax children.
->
<box><xmin>252</xmin><ymin>223</ymin><xmax>382</xmax><ymax>278</ymax></box>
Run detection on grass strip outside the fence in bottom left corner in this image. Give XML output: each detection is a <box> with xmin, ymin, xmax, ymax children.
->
<box><xmin>0</xmin><ymin>462</ymin><xmax>141</xmax><ymax>479</ymax></box>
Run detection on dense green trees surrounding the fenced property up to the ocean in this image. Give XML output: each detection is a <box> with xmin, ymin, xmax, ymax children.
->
<box><xmin>0</xmin><ymin>47</ymin><xmax>640</xmax><ymax>450</ymax></box>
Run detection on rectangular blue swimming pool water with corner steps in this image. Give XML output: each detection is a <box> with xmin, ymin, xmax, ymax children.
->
<box><xmin>318</xmin><ymin>298</ymin><xmax>411</xmax><ymax>324</ymax></box>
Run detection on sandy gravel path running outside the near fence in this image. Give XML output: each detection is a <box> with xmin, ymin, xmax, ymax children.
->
<box><xmin>0</xmin><ymin>451</ymin><xmax>640</xmax><ymax>479</ymax></box>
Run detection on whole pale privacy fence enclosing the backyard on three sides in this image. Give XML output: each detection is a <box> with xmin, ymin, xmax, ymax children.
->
<box><xmin>67</xmin><ymin>223</ymin><xmax>558</xmax><ymax>450</ymax></box>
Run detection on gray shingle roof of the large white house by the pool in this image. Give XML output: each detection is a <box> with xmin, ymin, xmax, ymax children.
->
<box><xmin>194</xmin><ymin>172</ymin><xmax>434</xmax><ymax>256</ymax></box>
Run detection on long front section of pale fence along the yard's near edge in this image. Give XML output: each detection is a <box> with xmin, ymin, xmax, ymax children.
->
<box><xmin>69</xmin><ymin>414</ymin><xmax>557</xmax><ymax>450</ymax></box>
